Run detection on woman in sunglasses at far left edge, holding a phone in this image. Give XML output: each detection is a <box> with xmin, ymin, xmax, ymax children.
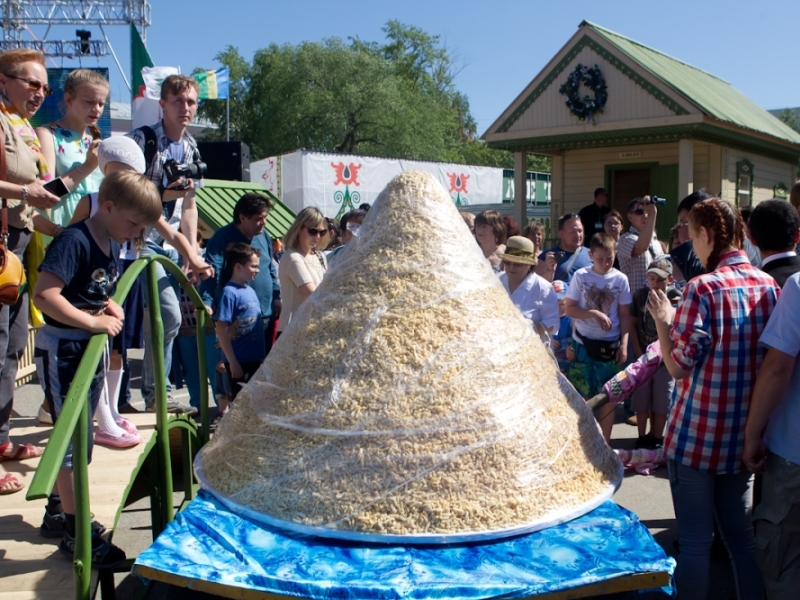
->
<box><xmin>0</xmin><ymin>49</ymin><xmax>58</xmax><ymax>476</ymax></box>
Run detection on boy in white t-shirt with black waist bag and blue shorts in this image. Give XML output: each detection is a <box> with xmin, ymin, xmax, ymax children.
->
<box><xmin>566</xmin><ymin>233</ymin><xmax>631</xmax><ymax>442</ymax></box>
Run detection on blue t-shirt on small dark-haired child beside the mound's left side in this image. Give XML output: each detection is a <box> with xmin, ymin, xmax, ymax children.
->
<box><xmin>216</xmin><ymin>281</ymin><xmax>267</xmax><ymax>363</ymax></box>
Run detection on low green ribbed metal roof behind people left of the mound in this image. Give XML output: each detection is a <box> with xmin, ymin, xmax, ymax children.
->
<box><xmin>197</xmin><ymin>179</ymin><xmax>295</xmax><ymax>239</ymax></box>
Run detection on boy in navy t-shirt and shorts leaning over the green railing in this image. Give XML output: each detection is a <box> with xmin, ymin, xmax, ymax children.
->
<box><xmin>33</xmin><ymin>171</ymin><xmax>161</xmax><ymax>569</ymax></box>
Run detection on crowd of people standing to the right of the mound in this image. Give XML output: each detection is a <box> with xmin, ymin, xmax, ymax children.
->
<box><xmin>465</xmin><ymin>182</ymin><xmax>800</xmax><ymax>600</ymax></box>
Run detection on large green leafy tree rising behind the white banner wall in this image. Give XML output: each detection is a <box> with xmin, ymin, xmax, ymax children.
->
<box><xmin>195</xmin><ymin>21</ymin><xmax>549</xmax><ymax>168</ymax></box>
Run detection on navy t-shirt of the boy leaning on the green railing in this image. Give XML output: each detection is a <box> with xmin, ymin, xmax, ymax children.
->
<box><xmin>39</xmin><ymin>221</ymin><xmax>120</xmax><ymax>329</ymax></box>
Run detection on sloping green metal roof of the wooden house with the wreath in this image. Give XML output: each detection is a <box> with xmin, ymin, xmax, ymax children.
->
<box><xmin>581</xmin><ymin>21</ymin><xmax>800</xmax><ymax>144</ymax></box>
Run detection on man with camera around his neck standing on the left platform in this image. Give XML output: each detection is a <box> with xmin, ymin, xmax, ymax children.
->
<box><xmin>127</xmin><ymin>75</ymin><xmax>210</xmax><ymax>414</ymax></box>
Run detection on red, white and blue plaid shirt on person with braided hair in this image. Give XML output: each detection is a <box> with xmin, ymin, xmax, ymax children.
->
<box><xmin>664</xmin><ymin>250</ymin><xmax>780</xmax><ymax>474</ymax></box>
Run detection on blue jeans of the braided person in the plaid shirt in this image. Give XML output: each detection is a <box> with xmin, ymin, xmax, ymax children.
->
<box><xmin>667</xmin><ymin>460</ymin><xmax>764</xmax><ymax>600</ymax></box>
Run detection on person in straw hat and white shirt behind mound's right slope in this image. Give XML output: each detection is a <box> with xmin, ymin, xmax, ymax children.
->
<box><xmin>498</xmin><ymin>236</ymin><xmax>561</xmax><ymax>334</ymax></box>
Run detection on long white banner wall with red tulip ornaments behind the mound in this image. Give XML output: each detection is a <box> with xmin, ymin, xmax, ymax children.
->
<box><xmin>250</xmin><ymin>151</ymin><xmax>503</xmax><ymax>218</ymax></box>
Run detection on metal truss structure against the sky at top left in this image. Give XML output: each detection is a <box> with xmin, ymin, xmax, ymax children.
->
<box><xmin>0</xmin><ymin>0</ymin><xmax>151</xmax><ymax>58</ymax></box>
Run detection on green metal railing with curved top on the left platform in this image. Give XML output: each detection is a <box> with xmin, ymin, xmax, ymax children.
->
<box><xmin>27</xmin><ymin>255</ymin><xmax>209</xmax><ymax>600</ymax></box>
